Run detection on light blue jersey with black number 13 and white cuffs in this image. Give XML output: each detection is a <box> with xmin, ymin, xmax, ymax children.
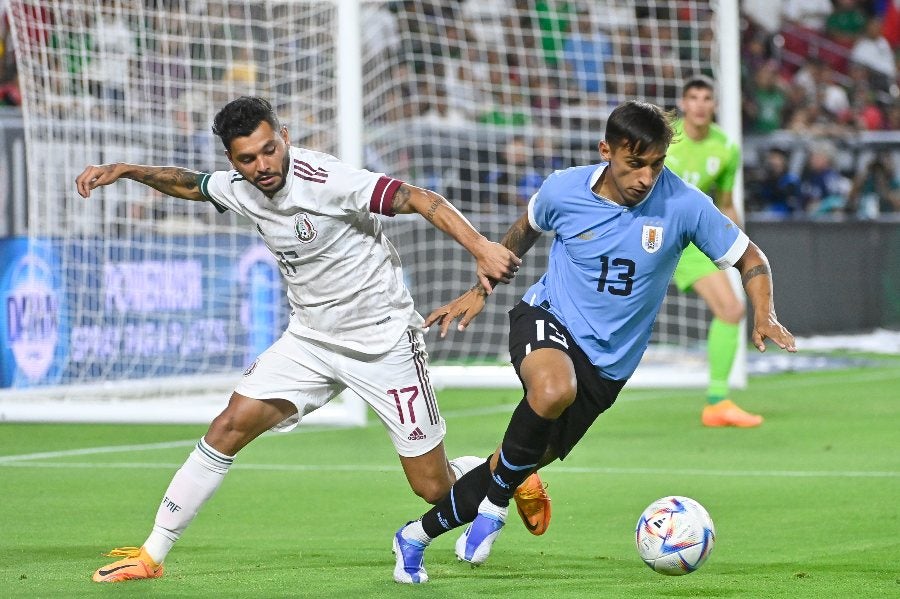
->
<box><xmin>522</xmin><ymin>163</ymin><xmax>750</xmax><ymax>380</ymax></box>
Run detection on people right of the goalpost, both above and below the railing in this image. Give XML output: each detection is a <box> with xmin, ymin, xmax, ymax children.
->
<box><xmin>742</xmin><ymin>0</ymin><xmax>900</xmax><ymax>219</ymax></box>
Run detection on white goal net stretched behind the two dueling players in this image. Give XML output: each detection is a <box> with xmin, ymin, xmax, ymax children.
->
<box><xmin>0</xmin><ymin>0</ymin><xmax>740</xmax><ymax>423</ymax></box>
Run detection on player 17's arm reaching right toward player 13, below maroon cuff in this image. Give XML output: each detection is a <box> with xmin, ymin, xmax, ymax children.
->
<box><xmin>393</xmin><ymin>183</ymin><xmax>522</xmax><ymax>294</ymax></box>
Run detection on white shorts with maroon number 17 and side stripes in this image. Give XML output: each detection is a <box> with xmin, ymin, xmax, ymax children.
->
<box><xmin>234</xmin><ymin>329</ymin><xmax>446</xmax><ymax>457</ymax></box>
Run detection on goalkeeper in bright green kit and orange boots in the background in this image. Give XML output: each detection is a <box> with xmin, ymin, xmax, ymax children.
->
<box><xmin>666</xmin><ymin>76</ymin><xmax>763</xmax><ymax>427</ymax></box>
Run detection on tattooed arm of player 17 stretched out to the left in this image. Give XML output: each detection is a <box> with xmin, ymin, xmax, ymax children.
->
<box><xmin>75</xmin><ymin>162</ymin><xmax>206</xmax><ymax>201</ymax></box>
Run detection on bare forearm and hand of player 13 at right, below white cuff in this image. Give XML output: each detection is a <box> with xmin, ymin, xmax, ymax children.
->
<box><xmin>735</xmin><ymin>242</ymin><xmax>797</xmax><ymax>352</ymax></box>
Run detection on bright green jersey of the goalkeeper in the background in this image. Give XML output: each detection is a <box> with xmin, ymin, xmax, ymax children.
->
<box><xmin>666</xmin><ymin>119</ymin><xmax>741</xmax><ymax>198</ymax></box>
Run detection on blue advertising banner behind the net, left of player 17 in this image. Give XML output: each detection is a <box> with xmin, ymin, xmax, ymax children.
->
<box><xmin>0</xmin><ymin>234</ymin><xmax>289</xmax><ymax>387</ymax></box>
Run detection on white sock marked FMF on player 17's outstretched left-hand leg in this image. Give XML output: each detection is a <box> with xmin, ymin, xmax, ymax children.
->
<box><xmin>144</xmin><ymin>438</ymin><xmax>234</xmax><ymax>564</ymax></box>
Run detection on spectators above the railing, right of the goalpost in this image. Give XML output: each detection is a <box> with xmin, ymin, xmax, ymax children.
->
<box><xmin>742</xmin><ymin>0</ymin><xmax>900</xmax><ymax>135</ymax></box>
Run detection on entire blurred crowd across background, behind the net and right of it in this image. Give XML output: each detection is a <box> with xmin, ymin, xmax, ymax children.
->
<box><xmin>0</xmin><ymin>0</ymin><xmax>900</xmax><ymax>218</ymax></box>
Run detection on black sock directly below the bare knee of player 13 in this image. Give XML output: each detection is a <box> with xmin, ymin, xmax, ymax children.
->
<box><xmin>487</xmin><ymin>399</ymin><xmax>554</xmax><ymax>507</ymax></box>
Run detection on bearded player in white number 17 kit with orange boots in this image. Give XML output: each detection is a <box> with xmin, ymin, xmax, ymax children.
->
<box><xmin>76</xmin><ymin>97</ymin><xmax>549</xmax><ymax>582</ymax></box>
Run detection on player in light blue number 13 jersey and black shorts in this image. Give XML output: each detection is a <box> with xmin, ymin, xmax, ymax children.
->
<box><xmin>394</xmin><ymin>101</ymin><xmax>796</xmax><ymax>583</ymax></box>
